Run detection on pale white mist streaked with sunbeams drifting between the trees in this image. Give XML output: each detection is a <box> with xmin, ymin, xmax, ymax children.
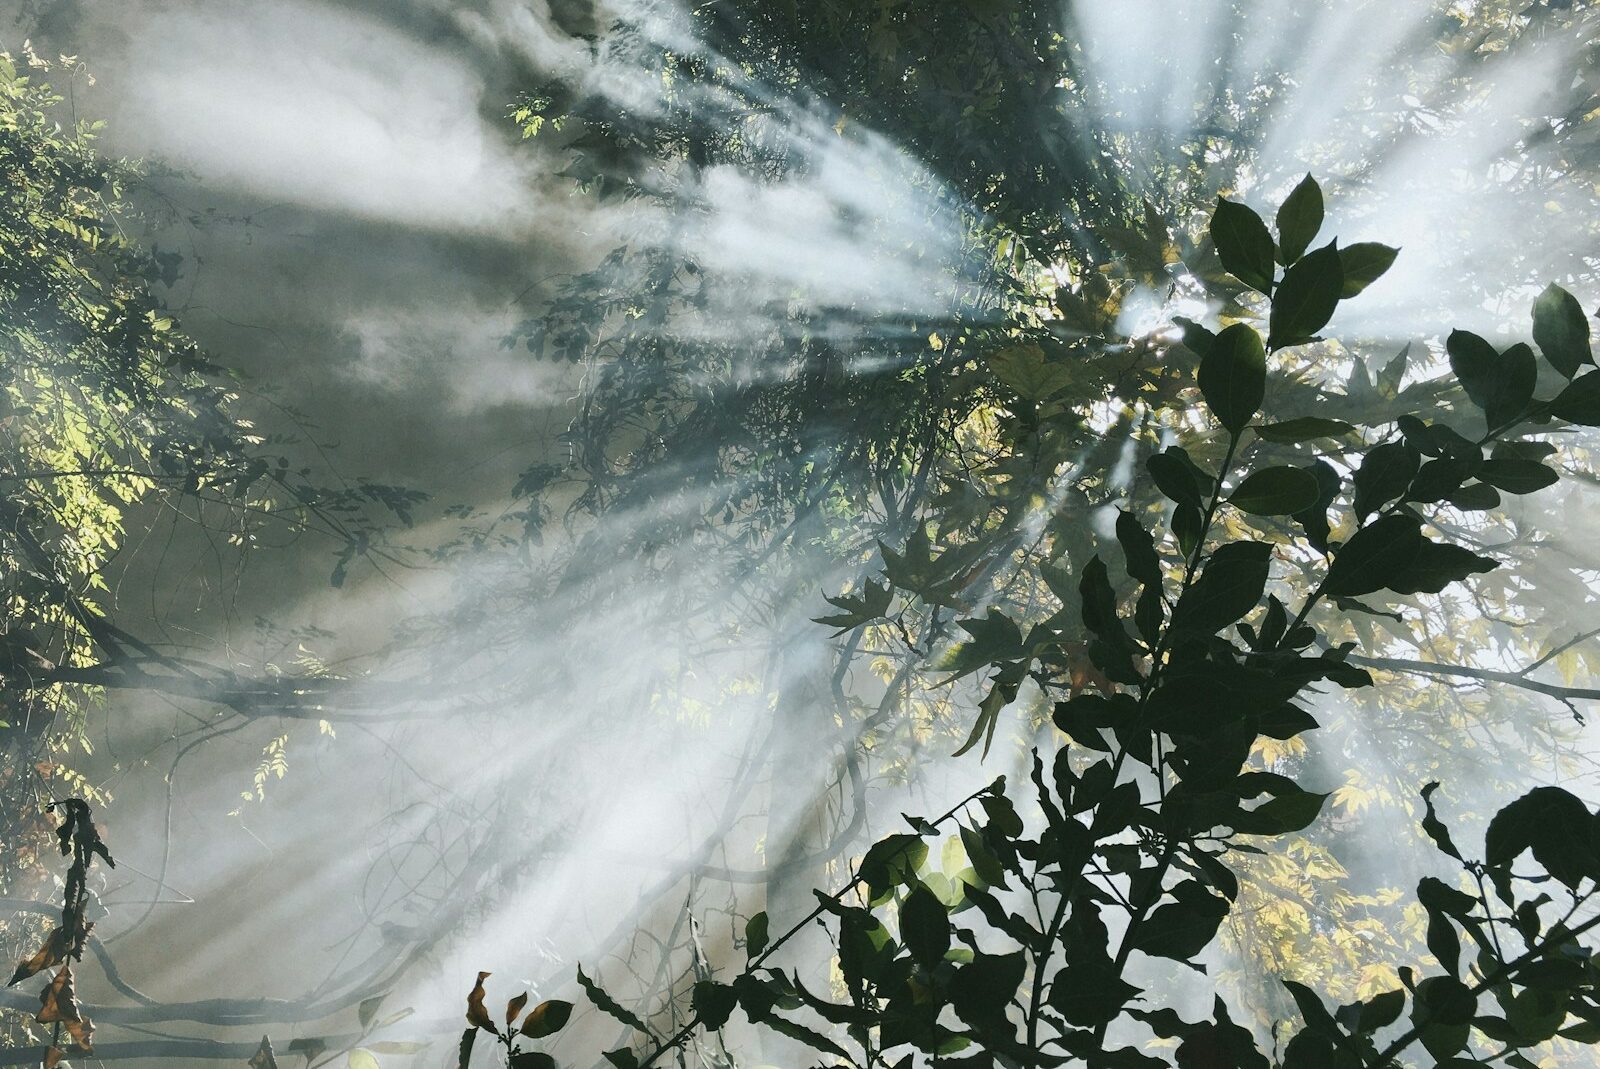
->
<box><xmin>0</xmin><ymin>0</ymin><xmax>1600</xmax><ymax>1066</ymax></box>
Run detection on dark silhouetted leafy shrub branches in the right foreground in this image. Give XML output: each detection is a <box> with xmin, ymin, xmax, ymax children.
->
<box><xmin>537</xmin><ymin>181</ymin><xmax>1600</xmax><ymax>1069</ymax></box>
